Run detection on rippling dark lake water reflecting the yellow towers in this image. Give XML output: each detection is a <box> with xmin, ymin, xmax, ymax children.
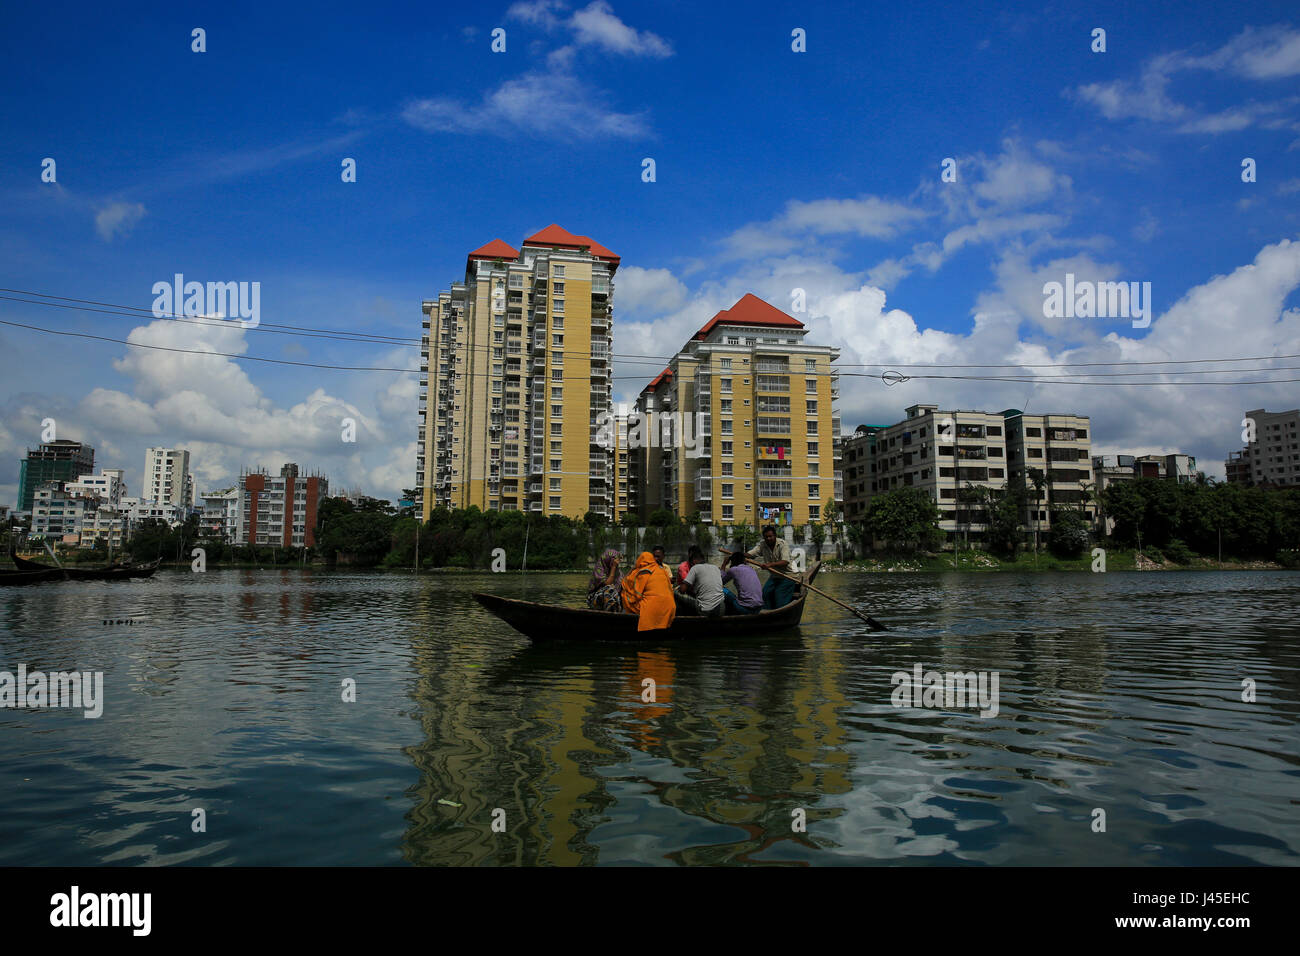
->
<box><xmin>0</xmin><ymin>570</ymin><xmax>1300</xmax><ymax>866</ymax></box>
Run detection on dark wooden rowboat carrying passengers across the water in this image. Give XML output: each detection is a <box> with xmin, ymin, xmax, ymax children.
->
<box><xmin>473</xmin><ymin>562</ymin><xmax>820</xmax><ymax>643</ymax></box>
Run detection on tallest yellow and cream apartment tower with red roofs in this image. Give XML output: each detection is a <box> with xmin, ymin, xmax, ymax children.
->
<box><xmin>416</xmin><ymin>225</ymin><xmax>620</xmax><ymax>519</ymax></box>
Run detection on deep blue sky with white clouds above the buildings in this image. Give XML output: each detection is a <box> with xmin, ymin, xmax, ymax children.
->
<box><xmin>0</xmin><ymin>0</ymin><xmax>1300</xmax><ymax>503</ymax></box>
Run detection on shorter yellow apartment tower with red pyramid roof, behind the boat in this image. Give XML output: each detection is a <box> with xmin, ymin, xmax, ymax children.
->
<box><xmin>628</xmin><ymin>295</ymin><xmax>840</xmax><ymax>525</ymax></box>
